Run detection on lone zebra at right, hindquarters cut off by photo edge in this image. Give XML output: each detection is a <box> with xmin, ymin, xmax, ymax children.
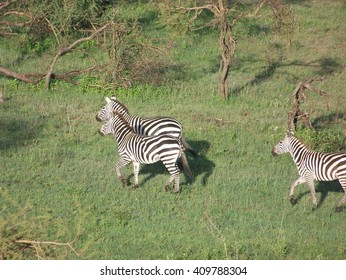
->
<box><xmin>272</xmin><ymin>132</ymin><xmax>346</xmax><ymax>212</ymax></box>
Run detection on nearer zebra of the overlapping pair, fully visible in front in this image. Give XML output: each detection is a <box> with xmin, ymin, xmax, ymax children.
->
<box><xmin>99</xmin><ymin>111</ymin><xmax>193</xmax><ymax>193</ymax></box>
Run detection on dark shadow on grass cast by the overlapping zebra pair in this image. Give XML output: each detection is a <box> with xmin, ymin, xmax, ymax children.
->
<box><xmin>127</xmin><ymin>141</ymin><xmax>215</xmax><ymax>187</ymax></box>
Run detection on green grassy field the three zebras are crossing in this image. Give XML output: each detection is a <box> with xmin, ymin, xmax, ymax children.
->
<box><xmin>0</xmin><ymin>0</ymin><xmax>346</xmax><ymax>259</ymax></box>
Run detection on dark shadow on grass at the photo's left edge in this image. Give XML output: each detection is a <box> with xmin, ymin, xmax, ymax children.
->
<box><xmin>0</xmin><ymin>119</ymin><xmax>43</xmax><ymax>150</ymax></box>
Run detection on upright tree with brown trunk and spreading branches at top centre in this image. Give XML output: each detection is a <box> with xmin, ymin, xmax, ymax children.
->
<box><xmin>161</xmin><ymin>0</ymin><xmax>294</xmax><ymax>98</ymax></box>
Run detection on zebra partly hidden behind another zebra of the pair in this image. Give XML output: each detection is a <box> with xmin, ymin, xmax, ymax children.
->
<box><xmin>96</xmin><ymin>96</ymin><xmax>196</xmax><ymax>155</ymax></box>
